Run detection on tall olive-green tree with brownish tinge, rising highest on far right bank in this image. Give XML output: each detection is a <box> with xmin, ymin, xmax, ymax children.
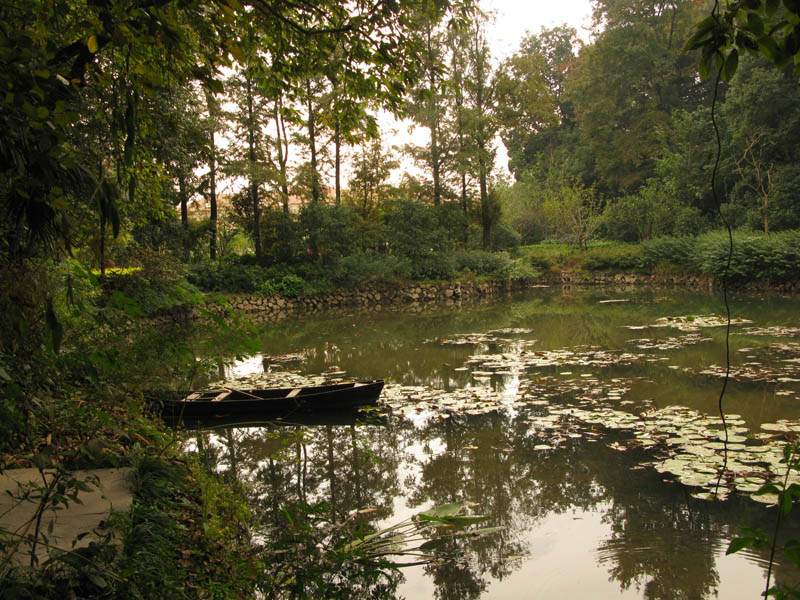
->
<box><xmin>568</xmin><ymin>0</ymin><xmax>709</xmax><ymax>193</ymax></box>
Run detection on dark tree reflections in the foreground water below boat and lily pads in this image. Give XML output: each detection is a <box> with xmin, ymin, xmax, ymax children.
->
<box><xmin>189</xmin><ymin>409</ymin><xmax>797</xmax><ymax>600</ymax></box>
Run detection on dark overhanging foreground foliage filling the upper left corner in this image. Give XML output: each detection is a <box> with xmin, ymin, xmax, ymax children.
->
<box><xmin>0</xmin><ymin>0</ymin><xmax>472</xmax><ymax>257</ymax></box>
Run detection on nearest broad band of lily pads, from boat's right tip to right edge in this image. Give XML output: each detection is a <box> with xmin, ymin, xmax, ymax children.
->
<box><xmin>378</xmin><ymin>378</ymin><xmax>800</xmax><ymax>503</ymax></box>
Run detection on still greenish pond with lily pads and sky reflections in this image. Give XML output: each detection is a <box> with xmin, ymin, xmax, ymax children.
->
<box><xmin>180</xmin><ymin>288</ymin><xmax>800</xmax><ymax>600</ymax></box>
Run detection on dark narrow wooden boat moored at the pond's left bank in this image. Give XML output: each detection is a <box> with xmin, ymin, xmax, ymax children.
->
<box><xmin>156</xmin><ymin>380</ymin><xmax>383</xmax><ymax>419</ymax></box>
